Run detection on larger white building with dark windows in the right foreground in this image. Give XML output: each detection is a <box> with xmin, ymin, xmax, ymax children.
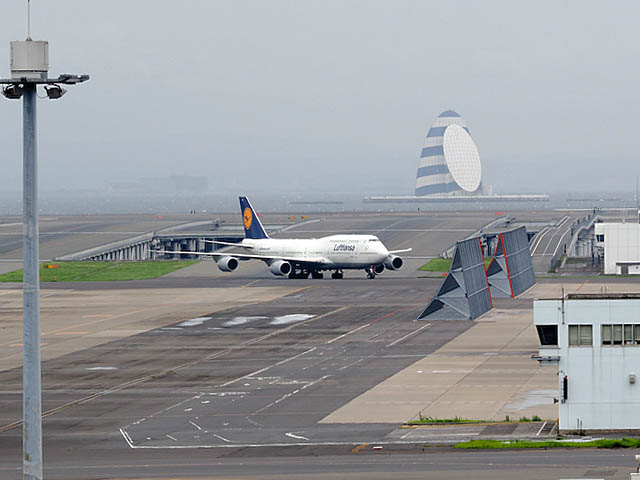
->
<box><xmin>533</xmin><ymin>294</ymin><xmax>640</xmax><ymax>432</ymax></box>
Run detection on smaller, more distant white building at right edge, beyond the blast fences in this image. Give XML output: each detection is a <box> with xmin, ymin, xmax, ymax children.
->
<box><xmin>595</xmin><ymin>223</ymin><xmax>640</xmax><ymax>275</ymax></box>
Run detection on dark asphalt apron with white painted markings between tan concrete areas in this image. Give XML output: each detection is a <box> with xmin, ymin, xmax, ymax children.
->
<box><xmin>0</xmin><ymin>279</ymin><xmax>471</xmax><ymax>478</ymax></box>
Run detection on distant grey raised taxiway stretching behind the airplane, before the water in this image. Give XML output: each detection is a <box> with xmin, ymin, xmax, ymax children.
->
<box><xmin>0</xmin><ymin>210</ymin><xmax>566</xmax><ymax>276</ymax></box>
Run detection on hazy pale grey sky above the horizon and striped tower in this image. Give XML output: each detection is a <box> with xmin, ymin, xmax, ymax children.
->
<box><xmin>0</xmin><ymin>0</ymin><xmax>640</xmax><ymax>194</ymax></box>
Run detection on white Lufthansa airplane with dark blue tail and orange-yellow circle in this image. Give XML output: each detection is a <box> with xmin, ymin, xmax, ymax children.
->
<box><xmin>158</xmin><ymin>197</ymin><xmax>411</xmax><ymax>278</ymax></box>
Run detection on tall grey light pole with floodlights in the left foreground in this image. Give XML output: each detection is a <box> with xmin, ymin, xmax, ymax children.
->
<box><xmin>0</xmin><ymin>37</ymin><xmax>89</xmax><ymax>480</ymax></box>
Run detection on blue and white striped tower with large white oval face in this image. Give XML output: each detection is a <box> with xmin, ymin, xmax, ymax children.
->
<box><xmin>415</xmin><ymin>110</ymin><xmax>482</xmax><ymax>196</ymax></box>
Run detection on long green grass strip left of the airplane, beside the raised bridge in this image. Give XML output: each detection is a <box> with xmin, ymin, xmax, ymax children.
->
<box><xmin>0</xmin><ymin>260</ymin><xmax>199</xmax><ymax>283</ymax></box>
